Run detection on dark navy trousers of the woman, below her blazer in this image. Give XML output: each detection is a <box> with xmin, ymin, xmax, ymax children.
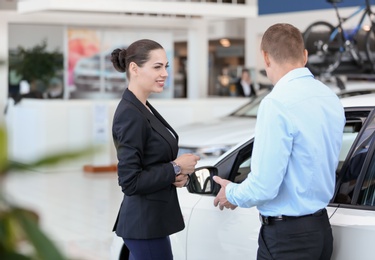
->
<box><xmin>124</xmin><ymin>237</ymin><xmax>173</xmax><ymax>260</ymax></box>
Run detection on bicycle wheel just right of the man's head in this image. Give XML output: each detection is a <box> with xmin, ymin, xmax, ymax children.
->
<box><xmin>303</xmin><ymin>21</ymin><xmax>344</xmax><ymax>75</ymax></box>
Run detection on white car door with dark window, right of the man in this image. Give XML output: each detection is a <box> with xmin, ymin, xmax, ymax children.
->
<box><xmin>330</xmin><ymin>108</ymin><xmax>375</xmax><ymax>260</ymax></box>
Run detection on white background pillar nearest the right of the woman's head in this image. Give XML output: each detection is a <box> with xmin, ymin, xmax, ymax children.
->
<box><xmin>187</xmin><ymin>19</ymin><xmax>208</xmax><ymax>99</ymax></box>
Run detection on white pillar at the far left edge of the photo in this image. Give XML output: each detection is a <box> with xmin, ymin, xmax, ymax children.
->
<box><xmin>0</xmin><ymin>11</ymin><xmax>9</xmax><ymax>121</ymax></box>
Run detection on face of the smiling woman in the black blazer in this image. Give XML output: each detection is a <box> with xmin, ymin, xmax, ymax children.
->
<box><xmin>136</xmin><ymin>49</ymin><xmax>169</xmax><ymax>93</ymax></box>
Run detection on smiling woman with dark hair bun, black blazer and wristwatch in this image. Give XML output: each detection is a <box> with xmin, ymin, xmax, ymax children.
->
<box><xmin>111</xmin><ymin>39</ymin><xmax>199</xmax><ymax>260</ymax></box>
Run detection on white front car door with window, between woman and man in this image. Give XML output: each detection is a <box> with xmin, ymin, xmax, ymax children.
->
<box><xmin>187</xmin><ymin>140</ymin><xmax>260</xmax><ymax>260</ymax></box>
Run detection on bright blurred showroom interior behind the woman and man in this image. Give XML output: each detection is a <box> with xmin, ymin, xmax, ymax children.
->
<box><xmin>0</xmin><ymin>0</ymin><xmax>374</xmax><ymax>260</ymax></box>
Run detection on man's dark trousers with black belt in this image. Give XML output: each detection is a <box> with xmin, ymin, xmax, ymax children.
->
<box><xmin>257</xmin><ymin>210</ymin><xmax>333</xmax><ymax>260</ymax></box>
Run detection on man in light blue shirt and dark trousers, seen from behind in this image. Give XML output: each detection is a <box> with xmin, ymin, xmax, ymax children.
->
<box><xmin>214</xmin><ymin>24</ymin><xmax>345</xmax><ymax>260</ymax></box>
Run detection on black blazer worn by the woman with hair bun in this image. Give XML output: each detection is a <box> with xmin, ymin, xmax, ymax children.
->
<box><xmin>112</xmin><ymin>89</ymin><xmax>185</xmax><ymax>239</ymax></box>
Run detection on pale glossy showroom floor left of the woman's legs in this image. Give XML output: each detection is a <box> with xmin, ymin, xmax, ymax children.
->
<box><xmin>5</xmin><ymin>168</ymin><xmax>122</xmax><ymax>260</ymax></box>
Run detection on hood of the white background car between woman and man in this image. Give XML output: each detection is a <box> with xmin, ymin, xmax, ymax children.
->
<box><xmin>176</xmin><ymin>116</ymin><xmax>256</xmax><ymax>147</ymax></box>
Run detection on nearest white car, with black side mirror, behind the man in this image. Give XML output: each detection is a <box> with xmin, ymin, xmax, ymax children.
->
<box><xmin>112</xmin><ymin>94</ymin><xmax>375</xmax><ymax>260</ymax></box>
